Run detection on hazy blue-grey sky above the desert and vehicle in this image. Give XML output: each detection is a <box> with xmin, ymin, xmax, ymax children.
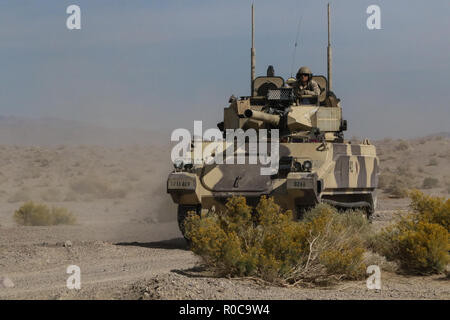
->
<box><xmin>0</xmin><ymin>0</ymin><xmax>450</xmax><ymax>138</ymax></box>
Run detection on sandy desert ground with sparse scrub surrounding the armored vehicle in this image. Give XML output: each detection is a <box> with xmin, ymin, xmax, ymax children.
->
<box><xmin>0</xmin><ymin>119</ymin><xmax>450</xmax><ymax>299</ymax></box>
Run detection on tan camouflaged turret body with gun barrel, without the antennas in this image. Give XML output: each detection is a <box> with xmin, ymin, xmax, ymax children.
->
<box><xmin>225</xmin><ymin>84</ymin><xmax>347</xmax><ymax>142</ymax></box>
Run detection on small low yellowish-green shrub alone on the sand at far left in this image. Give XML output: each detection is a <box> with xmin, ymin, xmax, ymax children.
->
<box><xmin>13</xmin><ymin>201</ymin><xmax>76</xmax><ymax>226</ymax></box>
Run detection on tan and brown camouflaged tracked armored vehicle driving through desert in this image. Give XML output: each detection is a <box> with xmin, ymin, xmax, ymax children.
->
<box><xmin>167</xmin><ymin>3</ymin><xmax>379</xmax><ymax>238</ymax></box>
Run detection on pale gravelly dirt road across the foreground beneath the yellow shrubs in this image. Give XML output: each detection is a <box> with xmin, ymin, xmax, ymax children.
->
<box><xmin>0</xmin><ymin>211</ymin><xmax>450</xmax><ymax>299</ymax></box>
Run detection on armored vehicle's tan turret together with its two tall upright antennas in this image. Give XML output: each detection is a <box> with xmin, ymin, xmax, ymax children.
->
<box><xmin>218</xmin><ymin>4</ymin><xmax>347</xmax><ymax>141</ymax></box>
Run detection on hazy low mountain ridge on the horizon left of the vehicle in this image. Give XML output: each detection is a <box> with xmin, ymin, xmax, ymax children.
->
<box><xmin>0</xmin><ymin>116</ymin><xmax>170</xmax><ymax>146</ymax></box>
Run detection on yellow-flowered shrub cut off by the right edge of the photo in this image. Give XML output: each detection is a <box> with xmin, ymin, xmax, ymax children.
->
<box><xmin>372</xmin><ymin>191</ymin><xmax>450</xmax><ymax>274</ymax></box>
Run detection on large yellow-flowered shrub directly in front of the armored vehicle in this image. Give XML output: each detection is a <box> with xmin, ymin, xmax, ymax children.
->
<box><xmin>185</xmin><ymin>197</ymin><xmax>367</xmax><ymax>284</ymax></box>
